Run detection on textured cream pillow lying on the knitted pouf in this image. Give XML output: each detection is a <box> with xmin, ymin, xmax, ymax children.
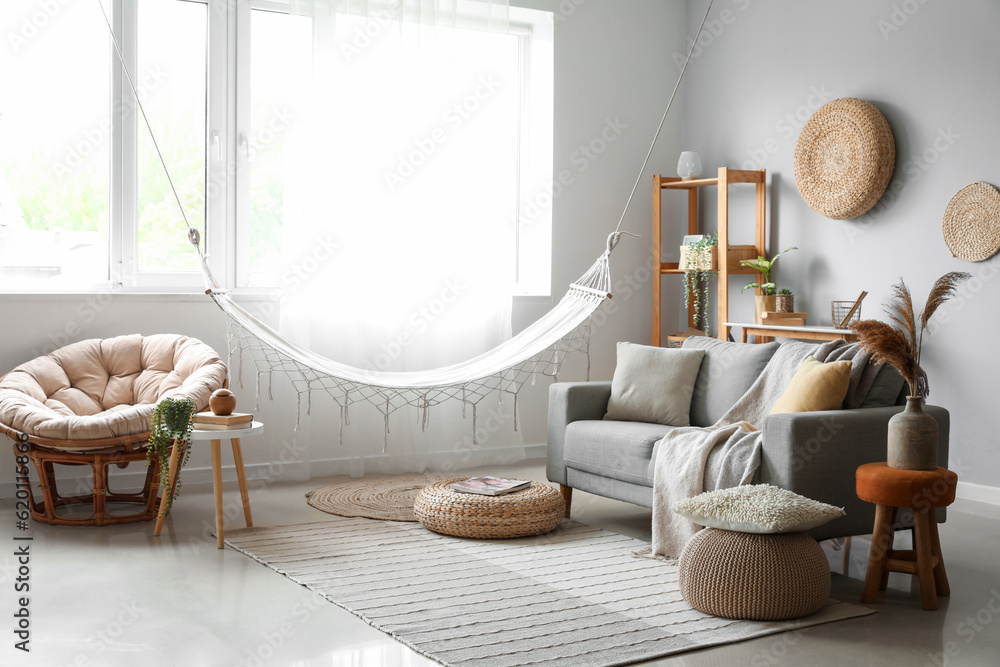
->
<box><xmin>673</xmin><ymin>484</ymin><xmax>846</xmax><ymax>533</ymax></box>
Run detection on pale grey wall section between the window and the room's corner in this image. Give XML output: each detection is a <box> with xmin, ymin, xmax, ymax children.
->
<box><xmin>512</xmin><ymin>0</ymin><xmax>685</xmax><ymax>452</ymax></box>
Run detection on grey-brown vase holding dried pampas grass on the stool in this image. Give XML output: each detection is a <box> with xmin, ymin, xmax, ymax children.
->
<box><xmin>850</xmin><ymin>271</ymin><xmax>970</xmax><ymax>470</ymax></box>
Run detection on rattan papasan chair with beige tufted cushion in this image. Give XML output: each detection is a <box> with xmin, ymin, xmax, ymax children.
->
<box><xmin>0</xmin><ymin>334</ymin><xmax>227</xmax><ymax>526</ymax></box>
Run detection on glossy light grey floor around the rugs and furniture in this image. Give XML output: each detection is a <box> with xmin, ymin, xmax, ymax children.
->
<box><xmin>0</xmin><ymin>461</ymin><xmax>1000</xmax><ymax>667</ymax></box>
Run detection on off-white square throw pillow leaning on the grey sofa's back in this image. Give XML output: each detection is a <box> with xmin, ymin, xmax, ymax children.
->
<box><xmin>604</xmin><ymin>343</ymin><xmax>705</xmax><ymax>426</ymax></box>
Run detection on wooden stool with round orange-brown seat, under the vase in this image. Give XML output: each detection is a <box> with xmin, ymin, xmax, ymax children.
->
<box><xmin>856</xmin><ymin>463</ymin><xmax>958</xmax><ymax>609</ymax></box>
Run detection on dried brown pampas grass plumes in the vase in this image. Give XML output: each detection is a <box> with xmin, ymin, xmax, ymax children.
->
<box><xmin>851</xmin><ymin>271</ymin><xmax>971</xmax><ymax>396</ymax></box>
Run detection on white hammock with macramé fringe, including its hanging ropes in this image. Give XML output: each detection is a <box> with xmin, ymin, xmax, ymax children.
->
<box><xmin>102</xmin><ymin>0</ymin><xmax>714</xmax><ymax>452</ymax></box>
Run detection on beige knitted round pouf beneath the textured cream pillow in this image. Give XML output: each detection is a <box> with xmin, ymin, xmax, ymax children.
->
<box><xmin>678</xmin><ymin>528</ymin><xmax>830</xmax><ymax>621</ymax></box>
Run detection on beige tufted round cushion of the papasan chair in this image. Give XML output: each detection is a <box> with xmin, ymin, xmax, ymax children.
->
<box><xmin>0</xmin><ymin>334</ymin><xmax>226</xmax><ymax>450</ymax></box>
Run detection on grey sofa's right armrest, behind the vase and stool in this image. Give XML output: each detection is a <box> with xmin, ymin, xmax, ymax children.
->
<box><xmin>760</xmin><ymin>405</ymin><xmax>950</xmax><ymax>539</ymax></box>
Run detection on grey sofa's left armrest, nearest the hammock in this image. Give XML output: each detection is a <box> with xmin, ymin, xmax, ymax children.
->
<box><xmin>545</xmin><ymin>382</ymin><xmax>611</xmax><ymax>484</ymax></box>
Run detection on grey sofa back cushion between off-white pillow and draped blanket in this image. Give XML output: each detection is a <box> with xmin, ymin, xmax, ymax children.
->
<box><xmin>682</xmin><ymin>336</ymin><xmax>779</xmax><ymax>426</ymax></box>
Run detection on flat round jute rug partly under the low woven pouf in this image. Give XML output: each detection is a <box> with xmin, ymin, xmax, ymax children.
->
<box><xmin>306</xmin><ymin>473</ymin><xmax>456</xmax><ymax>521</ymax></box>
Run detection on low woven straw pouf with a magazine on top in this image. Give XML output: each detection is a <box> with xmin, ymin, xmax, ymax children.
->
<box><xmin>413</xmin><ymin>477</ymin><xmax>566</xmax><ymax>538</ymax></box>
